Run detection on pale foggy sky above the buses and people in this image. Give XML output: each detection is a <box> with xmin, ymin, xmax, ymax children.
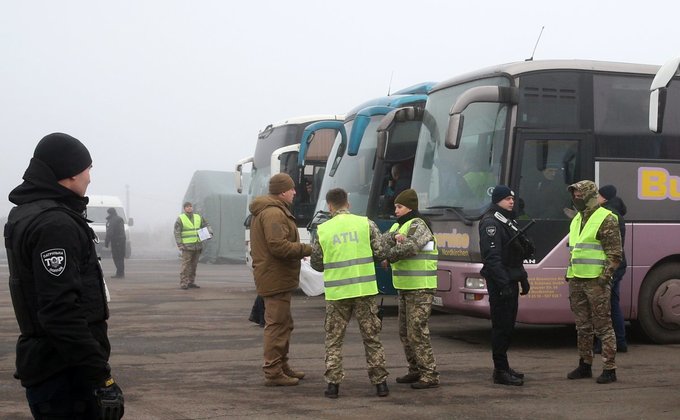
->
<box><xmin>0</xmin><ymin>0</ymin><xmax>680</xmax><ymax>253</ymax></box>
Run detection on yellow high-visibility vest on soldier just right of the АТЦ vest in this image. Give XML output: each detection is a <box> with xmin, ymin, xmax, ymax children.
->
<box><xmin>390</xmin><ymin>219</ymin><xmax>439</xmax><ymax>290</ymax></box>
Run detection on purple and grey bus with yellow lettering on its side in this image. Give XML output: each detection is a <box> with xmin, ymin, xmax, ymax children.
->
<box><xmin>380</xmin><ymin>60</ymin><xmax>680</xmax><ymax>343</ymax></box>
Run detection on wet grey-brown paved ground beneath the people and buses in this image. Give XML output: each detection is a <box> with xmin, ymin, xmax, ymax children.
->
<box><xmin>0</xmin><ymin>259</ymin><xmax>680</xmax><ymax>420</ymax></box>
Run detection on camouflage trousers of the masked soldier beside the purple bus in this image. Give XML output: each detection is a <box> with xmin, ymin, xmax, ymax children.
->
<box><xmin>569</xmin><ymin>278</ymin><xmax>616</xmax><ymax>369</ymax></box>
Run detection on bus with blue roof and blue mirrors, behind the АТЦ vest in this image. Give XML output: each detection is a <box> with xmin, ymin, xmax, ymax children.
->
<box><xmin>299</xmin><ymin>83</ymin><xmax>434</xmax><ymax>294</ymax></box>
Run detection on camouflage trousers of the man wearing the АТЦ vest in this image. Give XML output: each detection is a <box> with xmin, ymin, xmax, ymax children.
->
<box><xmin>324</xmin><ymin>296</ymin><xmax>388</xmax><ymax>385</ymax></box>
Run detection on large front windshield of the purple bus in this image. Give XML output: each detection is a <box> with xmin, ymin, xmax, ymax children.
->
<box><xmin>412</xmin><ymin>77</ymin><xmax>510</xmax><ymax>217</ymax></box>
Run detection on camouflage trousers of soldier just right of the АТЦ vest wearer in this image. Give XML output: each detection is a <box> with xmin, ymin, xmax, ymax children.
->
<box><xmin>399</xmin><ymin>289</ymin><xmax>439</xmax><ymax>383</ymax></box>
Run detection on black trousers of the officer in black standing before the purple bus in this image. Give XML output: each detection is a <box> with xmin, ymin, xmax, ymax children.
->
<box><xmin>487</xmin><ymin>281</ymin><xmax>519</xmax><ymax>370</ymax></box>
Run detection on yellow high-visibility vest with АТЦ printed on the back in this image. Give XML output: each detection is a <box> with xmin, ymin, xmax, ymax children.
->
<box><xmin>317</xmin><ymin>213</ymin><xmax>378</xmax><ymax>300</ymax></box>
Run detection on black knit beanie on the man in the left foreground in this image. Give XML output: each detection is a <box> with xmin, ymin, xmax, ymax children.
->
<box><xmin>33</xmin><ymin>133</ymin><xmax>92</xmax><ymax>181</ymax></box>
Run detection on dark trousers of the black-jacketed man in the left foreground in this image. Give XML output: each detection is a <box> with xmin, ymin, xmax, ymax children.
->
<box><xmin>26</xmin><ymin>369</ymin><xmax>100</xmax><ymax>420</ymax></box>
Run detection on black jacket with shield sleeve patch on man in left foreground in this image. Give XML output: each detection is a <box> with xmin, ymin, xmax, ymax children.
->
<box><xmin>4</xmin><ymin>159</ymin><xmax>111</xmax><ymax>386</ymax></box>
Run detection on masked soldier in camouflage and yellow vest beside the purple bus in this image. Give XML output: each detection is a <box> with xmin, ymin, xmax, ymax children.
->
<box><xmin>566</xmin><ymin>181</ymin><xmax>623</xmax><ymax>384</ymax></box>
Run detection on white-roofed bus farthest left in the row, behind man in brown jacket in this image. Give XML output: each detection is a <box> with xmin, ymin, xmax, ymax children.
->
<box><xmin>235</xmin><ymin>115</ymin><xmax>344</xmax><ymax>268</ymax></box>
